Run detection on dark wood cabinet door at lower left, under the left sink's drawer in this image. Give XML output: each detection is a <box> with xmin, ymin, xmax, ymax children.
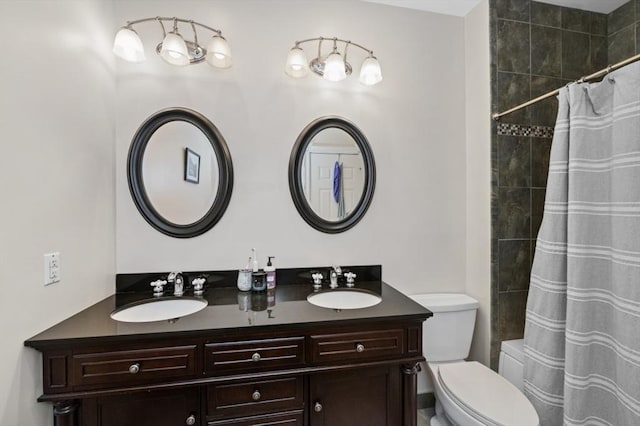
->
<box><xmin>81</xmin><ymin>388</ymin><xmax>201</xmax><ymax>426</ymax></box>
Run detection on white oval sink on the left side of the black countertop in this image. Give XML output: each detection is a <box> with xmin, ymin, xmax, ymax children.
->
<box><xmin>111</xmin><ymin>297</ymin><xmax>208</xmax><ymax>322</ymax></box>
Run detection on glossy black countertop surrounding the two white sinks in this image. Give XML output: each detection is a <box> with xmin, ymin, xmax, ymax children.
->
<box><xmin>25</xmin><ymin>266</ymin><xmax>432</xmax><ymax>349</ymax></box>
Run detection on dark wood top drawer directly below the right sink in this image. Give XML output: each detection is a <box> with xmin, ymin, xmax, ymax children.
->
<box><xmin>311</xmin><ymin>329</ymin><xmax>404</xmax><ymax>363</ymax></box>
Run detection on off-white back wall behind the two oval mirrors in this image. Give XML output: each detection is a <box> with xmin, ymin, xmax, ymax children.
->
<box><xmin>115</xmin><ymin>0</ymin><xmax>467</xmax><ymax>293</ymax></box>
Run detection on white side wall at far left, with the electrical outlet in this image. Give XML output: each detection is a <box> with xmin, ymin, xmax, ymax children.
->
<box><xmin>0</xmin><ymin>0</ymin><xmax>115</xmax><ymax>426</ymax></box>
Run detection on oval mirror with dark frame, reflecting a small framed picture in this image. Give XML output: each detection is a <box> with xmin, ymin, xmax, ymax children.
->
<box><xmin>127</xmin><ymin>108</ymin><xmax>233</xmax><ymax>238</ymax></box>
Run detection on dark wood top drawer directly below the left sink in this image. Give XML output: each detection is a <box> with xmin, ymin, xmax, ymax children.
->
<box><xmin>72</xmin><ymin>345</ymin><xmax>196</xmax><ymax>387</ymax></box>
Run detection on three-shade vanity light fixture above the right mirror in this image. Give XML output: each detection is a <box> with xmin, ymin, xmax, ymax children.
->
<box><xmin>285</xmin><ymin>37</ymin><xmax>382</xmax><ymax>86</ymax></box>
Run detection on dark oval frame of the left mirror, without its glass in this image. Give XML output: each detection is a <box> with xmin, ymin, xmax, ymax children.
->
<box><xmin>127</xmin><ymin>107</ymin><xmax>233</xmax><ymax>238</ymax></box>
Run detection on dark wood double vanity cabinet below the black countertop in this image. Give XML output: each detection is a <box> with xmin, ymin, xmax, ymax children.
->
<box><xmin>27</xmin><ymin>318</ymin><xmax>423</xmax><ymax>426</ymax></box>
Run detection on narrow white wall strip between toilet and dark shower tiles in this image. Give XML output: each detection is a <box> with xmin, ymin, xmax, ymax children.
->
<box><xmin>464</xmin><ymin>0</ymin><xmax>491</xmax><ymax>366</ymax></box>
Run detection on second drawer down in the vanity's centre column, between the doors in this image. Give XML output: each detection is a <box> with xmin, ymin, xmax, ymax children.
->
<box><xmin>207</xmin><ymin>377</ymin><xmax>304</xmax><ymax>418</ymax></box>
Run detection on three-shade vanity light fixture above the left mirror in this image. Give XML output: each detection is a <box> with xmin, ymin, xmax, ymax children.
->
<box><xmin>113</xmin><ymin>16</ymin><xmax>231</xmax><ymax>68</ymax></box>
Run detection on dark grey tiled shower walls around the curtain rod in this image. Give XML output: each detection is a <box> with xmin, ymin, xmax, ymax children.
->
<box><xmin>490</xmin><ymin>0</ymin><xmax>640</xmax><ymax>369</ymax></box>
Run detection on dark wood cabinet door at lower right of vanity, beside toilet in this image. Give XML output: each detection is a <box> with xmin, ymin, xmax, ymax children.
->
<box><xmin>309</xmin><ymin>366</ymin><xmax>402</xmax><ymax>426</ymax></box>
